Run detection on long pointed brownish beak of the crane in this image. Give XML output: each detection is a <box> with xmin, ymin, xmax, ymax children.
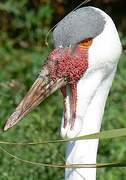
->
<box><xmin>4</xmin><ymin>65</ymin><xmax>66</xmax><ymax>131</ymax></box>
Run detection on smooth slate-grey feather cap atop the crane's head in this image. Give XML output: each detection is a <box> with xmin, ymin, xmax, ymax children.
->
<box><xmin>53</xmin><ymin>7</ymin><xmax>105</xmax><ymax>47</ymax></box>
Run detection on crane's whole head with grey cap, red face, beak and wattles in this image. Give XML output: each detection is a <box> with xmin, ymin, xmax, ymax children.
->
<box><xmin>4</xmin><ymin>7</ymin><xmax>121</xmax><ymax>137</ymax></box>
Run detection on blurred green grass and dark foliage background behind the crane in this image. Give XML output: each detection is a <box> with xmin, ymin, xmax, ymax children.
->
<box><xmin>0</xmin><ymin>0</ymin><xmax>126</xmax><ymax>180</ymax></box>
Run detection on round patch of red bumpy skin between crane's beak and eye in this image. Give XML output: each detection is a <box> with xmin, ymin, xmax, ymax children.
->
<box><xmin>49</xmin><ymin>47</ymin><xmax>88</xmax><ymax>84</ymax></box>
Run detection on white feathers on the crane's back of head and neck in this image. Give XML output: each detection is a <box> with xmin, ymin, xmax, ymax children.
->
<box><xmin>61</xmin><ymin>7</ymin><xmax>121</xmax><ymax>180</ymax></box>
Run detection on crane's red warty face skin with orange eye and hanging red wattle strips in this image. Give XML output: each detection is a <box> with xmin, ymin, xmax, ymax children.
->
<box><xmin>48</xmin><ymin>39</ymin><xmax>92</xmax><ymax>129</ymax></box>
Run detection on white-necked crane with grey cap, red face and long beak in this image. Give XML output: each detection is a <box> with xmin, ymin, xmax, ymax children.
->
<box><xmin>4</xmin><ymin>7</ymin><xmax>122</xmax><ymax>180</ymax></box>
